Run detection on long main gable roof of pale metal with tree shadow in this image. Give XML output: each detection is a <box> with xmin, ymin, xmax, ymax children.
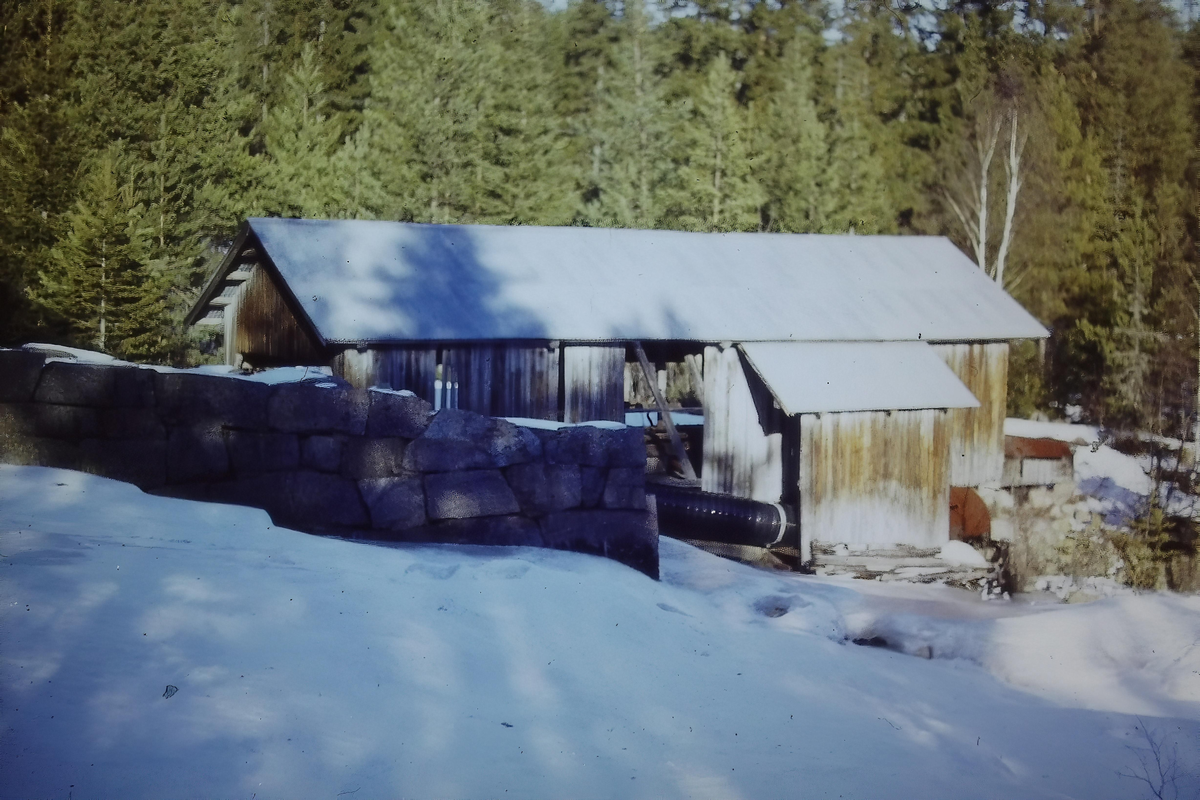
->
<box><xmin>238</xmin><ymin>218</ymin><xmax>1046</xmax><ymax>342</ymax></box>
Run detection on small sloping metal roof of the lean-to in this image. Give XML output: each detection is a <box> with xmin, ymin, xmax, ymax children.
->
<box><xmin>740</xmin><ymin>342</ymin><xmax>979</xmax><ymax>414</ymax></box>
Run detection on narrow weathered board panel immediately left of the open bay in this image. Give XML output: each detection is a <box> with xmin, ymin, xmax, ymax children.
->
<box><xmin>562</xmin><ymin>344</ymin><xmax>625</xmax><ymax>422</ymax></box>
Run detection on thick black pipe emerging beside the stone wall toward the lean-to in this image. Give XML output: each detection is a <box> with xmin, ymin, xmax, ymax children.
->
<box><xmin>646</xmin><ymin>483</ymin><xmax>796</xmax><ymax>547</ymax></box>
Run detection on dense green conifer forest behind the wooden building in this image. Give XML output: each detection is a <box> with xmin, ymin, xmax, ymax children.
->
<box><xmin>0</xmin><ymin>0</ymin><xmax>1200</xmax><ymax>435</ymax></box>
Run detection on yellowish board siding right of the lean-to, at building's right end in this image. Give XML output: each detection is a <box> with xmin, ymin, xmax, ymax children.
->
<box><xmin>934</xmin><ymin>342</ymin><xmax>1008</xmax><ymax>486</ymax></box>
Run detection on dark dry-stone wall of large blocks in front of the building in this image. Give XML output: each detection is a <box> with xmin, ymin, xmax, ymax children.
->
<box><xmin>0</xmin><ymin>350</ymin><xmax>658</xmax><ymax>577</ymax></box>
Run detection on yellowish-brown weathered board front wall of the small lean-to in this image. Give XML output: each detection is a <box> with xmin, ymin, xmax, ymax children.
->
<box><xmin>801</xmin><ymin>410</ymin><xmax>950</xmax><ymax>547</ymax></box>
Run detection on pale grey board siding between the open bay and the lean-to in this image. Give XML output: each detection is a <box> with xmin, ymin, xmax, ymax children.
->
<box><xmin>700</xmin><ymin>347</ymin><xmax>784</xmax><ymax>503</ymax></box>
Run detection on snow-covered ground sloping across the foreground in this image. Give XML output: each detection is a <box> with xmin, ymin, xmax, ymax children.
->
<box><xmin>0</xmin><ymin>467</ymin><xmax>1200</xmax><ymax>800</ymax></box>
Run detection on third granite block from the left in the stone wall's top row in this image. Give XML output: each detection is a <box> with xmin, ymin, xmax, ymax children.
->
<box><xmin>155</xmin><ymin>372</ymin><xmax>271</xmax><ymax>428</ymax></box>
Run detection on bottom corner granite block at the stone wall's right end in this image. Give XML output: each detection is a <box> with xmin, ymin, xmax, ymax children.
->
<box><xmin>540</xmin><ymin>509</ymin><xmax>659</xmax><ymax>579</ymax></box>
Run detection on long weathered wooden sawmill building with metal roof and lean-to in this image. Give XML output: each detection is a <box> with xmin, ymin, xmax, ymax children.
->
<box><xmin>188</xmin><ymin>218</ymin><xmax>1046</xmax><ymax>561</ymax></box>
